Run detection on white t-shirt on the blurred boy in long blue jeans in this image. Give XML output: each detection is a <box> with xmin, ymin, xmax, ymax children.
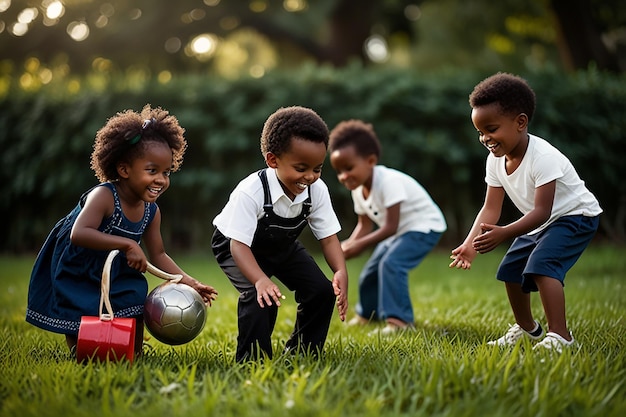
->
<box><xmin>352</xmin><ymin>165</ymin><xmax>447</xmax><ymax>236</ymax></box>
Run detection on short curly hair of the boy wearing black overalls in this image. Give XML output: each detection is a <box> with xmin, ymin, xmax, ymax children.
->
<box><xmin>261</xmin><ymin>106</ymin><xmax>328</xmax><ymax>157</ymax></box>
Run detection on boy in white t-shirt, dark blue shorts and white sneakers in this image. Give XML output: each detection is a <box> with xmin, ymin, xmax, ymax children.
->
<box><xmin>450</xmin><ymin>73</ymin><xmax>602</xmax><ymax>352</ymax></box>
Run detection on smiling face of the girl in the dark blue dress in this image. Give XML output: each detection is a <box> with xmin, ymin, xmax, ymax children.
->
<box><xmin>118</xmin><ymin>142</ymin><xmax>172</xmax><ymax>202</ymax></box>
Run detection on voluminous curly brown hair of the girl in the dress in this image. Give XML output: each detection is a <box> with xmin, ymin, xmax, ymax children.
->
<box><xmin>91</xmin><ymin>104</ymin><xmax>187</xmax><ymax>182</ymax></box>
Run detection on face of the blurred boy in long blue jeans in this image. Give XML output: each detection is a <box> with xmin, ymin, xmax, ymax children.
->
<box><xmin>330</xmin><ymin>141</ymin><xmax>378</xmax><ymax>191</ymax></box>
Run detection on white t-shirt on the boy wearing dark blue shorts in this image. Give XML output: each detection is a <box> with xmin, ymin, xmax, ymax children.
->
<box><xmin>485</xmin><ymin>135</ymin><xmax>602</xmax><ymax>235</ymax></box>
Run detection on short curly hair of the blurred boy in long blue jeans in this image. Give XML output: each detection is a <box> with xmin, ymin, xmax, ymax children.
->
<box><xmin>328</xmin><ymin>119</ymin><xmax>381</xmax><ymax>158</ymax></box>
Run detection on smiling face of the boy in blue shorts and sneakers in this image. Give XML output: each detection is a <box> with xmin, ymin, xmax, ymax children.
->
<box><xmin>472</xmin><ymin>103</ymin><xmax>528</xmax><ymax>157</ymax></box>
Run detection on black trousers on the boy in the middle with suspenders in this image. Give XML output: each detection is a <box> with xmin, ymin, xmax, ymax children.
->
<box><xmin>213</xmin><ymin>232</ymin><xmax>335</xmax><ymax>362</ymax></box>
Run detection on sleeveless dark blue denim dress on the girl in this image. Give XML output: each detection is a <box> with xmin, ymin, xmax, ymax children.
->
<box><xmin>26</xmin><ymin>182</ymin><xmax>157</xmax><ymax>335</ymax></box>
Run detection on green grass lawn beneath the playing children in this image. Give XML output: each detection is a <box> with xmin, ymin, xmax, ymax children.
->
<box><xmin>0</xmin><ymin>245</ymin><xmax>626</xmax><ymax>417</ymax></box>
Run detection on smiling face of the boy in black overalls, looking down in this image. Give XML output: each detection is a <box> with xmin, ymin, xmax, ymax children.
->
<box><xmin>265</xmin><ymin>137</ymin><xmax>326</xmax><ymax>200</ymax></box>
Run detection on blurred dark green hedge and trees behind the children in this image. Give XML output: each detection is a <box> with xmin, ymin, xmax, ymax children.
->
<box><xmin>0</xmin><ymin>0</ymin><xmax>626</xmax><ymax>252</ymax></box>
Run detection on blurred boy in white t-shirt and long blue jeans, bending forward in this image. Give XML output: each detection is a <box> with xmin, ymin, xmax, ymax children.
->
<box><xmin>328</xmin><ymin>120</ymin><xmax>446</xmax><ymax>335</ymax></box>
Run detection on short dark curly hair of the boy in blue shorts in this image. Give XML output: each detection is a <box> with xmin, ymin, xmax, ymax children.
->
<box><xmin>469</xmin><ymin>72</ymin><xmax>536</xmax><ymax>121</ymax></box>
